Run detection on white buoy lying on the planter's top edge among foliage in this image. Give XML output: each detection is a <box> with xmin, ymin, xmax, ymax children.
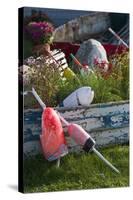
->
<box><xmin>62</xmin><ymin>87</ymin><xmax>94</xmax><ymax>107</ymax></box>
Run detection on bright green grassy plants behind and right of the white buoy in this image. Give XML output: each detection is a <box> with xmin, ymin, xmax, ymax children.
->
<box><xmin>55</xmin><ymin>52</ymin><xmax>129</xmax><ymax>103</ymax></box>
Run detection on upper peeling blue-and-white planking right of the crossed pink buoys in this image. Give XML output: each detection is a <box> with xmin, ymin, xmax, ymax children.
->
<box><xmin>60</xmin><ymin>103</ymin><xmax>129</xmax><ymax>131</ymax></box>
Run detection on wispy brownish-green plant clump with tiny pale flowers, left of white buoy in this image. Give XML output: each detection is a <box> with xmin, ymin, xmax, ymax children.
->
<box><xmin>25</xmin><ymin>57</ymin><xmax>61</xmax><ymax>106</ymax></box>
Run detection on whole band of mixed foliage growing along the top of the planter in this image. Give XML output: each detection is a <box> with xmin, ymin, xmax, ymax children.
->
<box><xmin>24</xmin><ymin>52</ymin><xmax>129</xmax><ymax>106</ymax></box>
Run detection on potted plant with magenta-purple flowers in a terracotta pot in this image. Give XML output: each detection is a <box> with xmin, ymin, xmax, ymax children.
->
<box><xmin>24</xmin><ymin>12</ymin><xmax>54</xmax><ymax>59</ymax></box>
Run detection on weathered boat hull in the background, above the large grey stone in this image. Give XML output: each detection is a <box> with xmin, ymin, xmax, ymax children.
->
<box><xmin>54</xmin><ymin>12</ymin><xmax>110</xmax><ymax>43</ymax></box>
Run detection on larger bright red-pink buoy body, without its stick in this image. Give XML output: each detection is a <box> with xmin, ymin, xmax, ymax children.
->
<box><xmin>40</xmin><ymin>107</ymin><xmax>68</xmax><ymax>161</ymax></box>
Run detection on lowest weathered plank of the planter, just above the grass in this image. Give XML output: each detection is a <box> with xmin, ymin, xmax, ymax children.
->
<box><xmin>24</xmin><ymin>127</ymin><xmax>129</xmax><ymax>156</ymax></box>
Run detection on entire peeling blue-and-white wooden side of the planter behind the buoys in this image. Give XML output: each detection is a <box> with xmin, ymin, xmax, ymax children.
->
<box><xmin>24</xmin><ymin>101</ymin><xmax>129</xmax><ymax>155</ymax></box>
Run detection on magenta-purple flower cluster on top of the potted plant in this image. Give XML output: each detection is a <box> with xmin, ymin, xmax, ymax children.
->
<box><xmin>25</xmin><ymin>22</ymin><xmax>54</xmax><ymax>44</ymax></box>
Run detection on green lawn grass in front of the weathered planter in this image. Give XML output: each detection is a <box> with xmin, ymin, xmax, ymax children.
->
<box><xmin>24</xmin><ymin>145</ymin><xmax>129</xmax><ymax>193</ymax></box>
